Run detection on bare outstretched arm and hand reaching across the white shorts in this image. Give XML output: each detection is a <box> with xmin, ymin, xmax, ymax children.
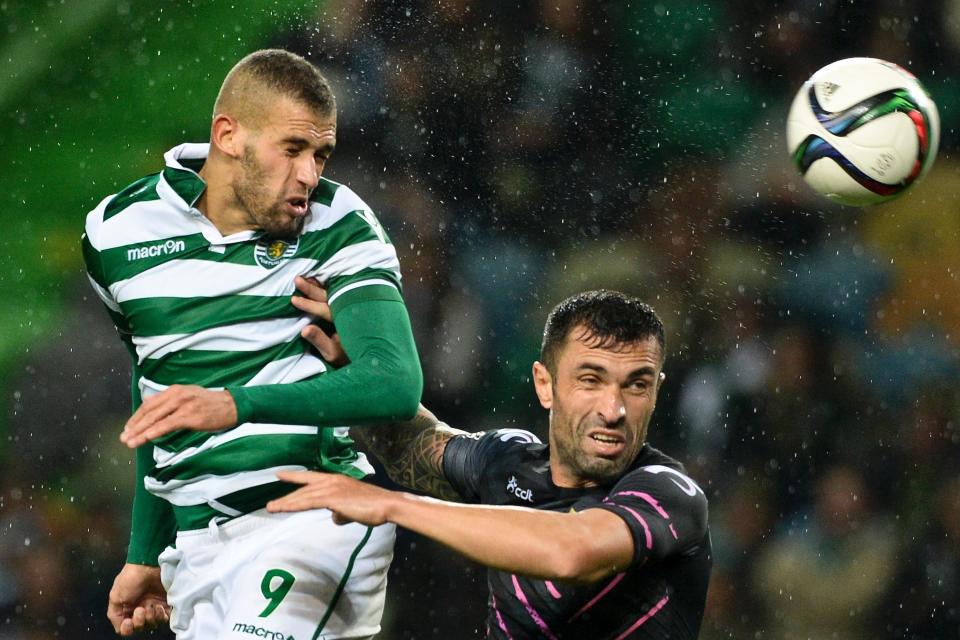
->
<box><xmin>267</xmin><ymin>471</ymin><xmax>634</xmax><ymax>582</ymax></box>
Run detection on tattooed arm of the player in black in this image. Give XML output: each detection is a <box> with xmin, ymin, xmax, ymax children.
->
<box><xmin>350</xmin><ymin>412</ymin><xmax>463</xmax><ymax>500</ymax></box>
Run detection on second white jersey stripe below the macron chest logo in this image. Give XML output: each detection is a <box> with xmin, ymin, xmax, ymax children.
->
<box><xmin>133</xmin><ymin>318</ymin><xmax>310</xmax><ymax>364</ymax></box>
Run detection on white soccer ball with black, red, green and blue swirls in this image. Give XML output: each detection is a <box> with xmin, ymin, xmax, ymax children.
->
<box><xmin>787</xmin><ymin>58</ymin><xmax>940</xmax><ymax>206</ymax></box>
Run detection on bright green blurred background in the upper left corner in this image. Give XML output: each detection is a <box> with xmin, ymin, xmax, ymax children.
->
<box><xmin>0</xmin><ymin>0</ymin><xmax>316</xmax><ymax>456</ymax></box>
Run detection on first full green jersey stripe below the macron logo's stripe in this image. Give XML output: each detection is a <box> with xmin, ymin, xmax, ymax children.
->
<box><xmin>120</xmin><ymin>296</ymin><xmax>302</xmax><ymax>336</ymax></box>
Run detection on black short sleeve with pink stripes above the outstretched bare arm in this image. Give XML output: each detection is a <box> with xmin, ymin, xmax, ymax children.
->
<box><xmin>590</xmin><ymin>465</ymin><xmax>707</xmax><ymax>564</ymax></box>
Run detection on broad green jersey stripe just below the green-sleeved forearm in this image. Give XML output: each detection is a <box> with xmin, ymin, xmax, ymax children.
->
<box><xmin>151</xmin><ymin>433</ymin><xmax>320</xmax><ymax>482</ymax></box>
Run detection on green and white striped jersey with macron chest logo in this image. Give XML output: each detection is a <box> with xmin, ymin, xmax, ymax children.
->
<box><xmin>83</xmin><ymin>144</ymin><xmax>400</xmax><ymax>528</ymax></box>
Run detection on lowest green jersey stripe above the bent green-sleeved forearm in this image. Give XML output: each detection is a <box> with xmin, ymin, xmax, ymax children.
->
<box><xmin>142</xmin><ymin>336</ymin><xmax>310</xmax><ymax>387</ymax></box>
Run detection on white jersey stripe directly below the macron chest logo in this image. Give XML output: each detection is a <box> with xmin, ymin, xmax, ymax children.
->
<box><xmin>110</xmin><ymin>258</ymin><xmax>317</xmax><ymax>303</ymax></box>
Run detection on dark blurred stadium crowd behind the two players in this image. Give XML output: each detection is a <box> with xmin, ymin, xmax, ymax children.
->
<box><xmin>0</xmin><ymin>0</ymin><xmax>960</xmax><ymax>640</ymax></box>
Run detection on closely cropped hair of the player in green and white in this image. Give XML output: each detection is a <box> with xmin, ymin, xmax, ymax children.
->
<box><xmin>213</xmin><ymin>49</ymin><xmax>337</xmax><ymax>129</ymax></box>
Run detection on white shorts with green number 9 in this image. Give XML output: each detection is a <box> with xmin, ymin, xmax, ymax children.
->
<box><xmin>160</xmin><ymin>509</ymin><xmax>395</xmax><ymax>640</ymax></box>
